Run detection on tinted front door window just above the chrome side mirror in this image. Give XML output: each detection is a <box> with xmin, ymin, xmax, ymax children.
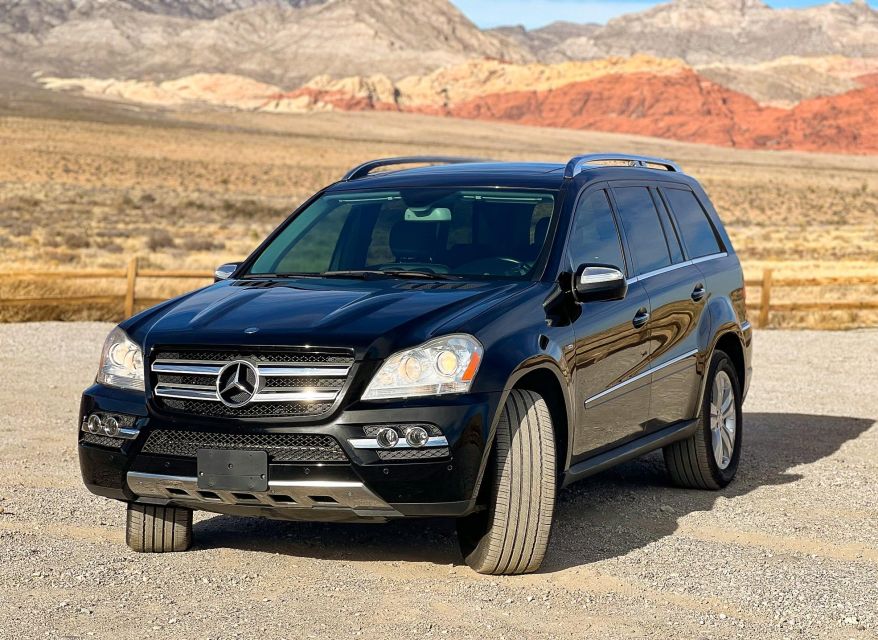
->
<box><xmin>569</xmin><ymin>191</ymin><xmax>625</xmax><ymax>271</ymax></box>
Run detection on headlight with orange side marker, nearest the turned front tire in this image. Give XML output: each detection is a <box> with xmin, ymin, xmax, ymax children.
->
<box><xmin>363</xmin><ymin>334</ymin><xmax>483</xmax><ymax>400</ymax></box>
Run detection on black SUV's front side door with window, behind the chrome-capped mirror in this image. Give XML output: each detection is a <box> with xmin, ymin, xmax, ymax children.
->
<box><xmin>567</xmin><ymin>189</ymin><xmax>649</xmax><ymax>463</ymax></box>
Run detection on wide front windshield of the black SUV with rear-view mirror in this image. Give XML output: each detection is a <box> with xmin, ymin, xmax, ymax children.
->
<box><xmin>247</xmin><ymin>189</ymin><xmax>555</xmax><ymax>279</ymax></box>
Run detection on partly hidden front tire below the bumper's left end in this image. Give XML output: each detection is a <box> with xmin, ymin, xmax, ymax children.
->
<box><xmin>125</xmin><ymin>504</ymin><xmax>192</xmax><ymax>553</ymax></box>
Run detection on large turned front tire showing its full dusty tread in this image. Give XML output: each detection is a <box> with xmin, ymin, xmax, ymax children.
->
<box><xmin>458</xmin><ymin>389</ymin><xmax>557</xmax><ymax>575</ymax></box>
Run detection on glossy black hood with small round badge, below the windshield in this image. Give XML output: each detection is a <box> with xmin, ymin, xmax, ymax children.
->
<box><xmin>134</xmin><ymin>279</ymin><xmax>532</xmax><ymax>359</ymax></box>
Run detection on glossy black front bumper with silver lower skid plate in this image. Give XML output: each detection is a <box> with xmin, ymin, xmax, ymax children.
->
<box><xmin>79</xmin><ymin>385</ymin><xmax>501</xmax><ymax>521</ymax></box>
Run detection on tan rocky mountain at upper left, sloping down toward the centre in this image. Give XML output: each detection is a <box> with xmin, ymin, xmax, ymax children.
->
<box><xmin>0</xmin><ymin>0</ymin><xmax>530</xmax><ymax>86</ymax></box>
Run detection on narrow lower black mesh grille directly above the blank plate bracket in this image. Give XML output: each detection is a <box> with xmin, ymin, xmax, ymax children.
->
<box><xmin>142</xmin><ymin>430</ymin><xmax>348</xmax><ymax>462</ymax></box>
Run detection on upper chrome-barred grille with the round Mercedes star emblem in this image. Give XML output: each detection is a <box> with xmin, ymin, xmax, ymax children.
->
<box><xmin>151</xmin><ymin>347</ymin><xmax>354</xmax><ymax>418</ymax></box>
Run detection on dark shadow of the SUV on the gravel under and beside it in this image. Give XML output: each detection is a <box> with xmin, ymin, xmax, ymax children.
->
<box><xmin>195</xmin><ymin>413</ymin><xmax>874</xmax><ymax>573</ymax></box>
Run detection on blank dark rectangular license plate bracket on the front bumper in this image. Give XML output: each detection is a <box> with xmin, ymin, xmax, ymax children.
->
<box><xmin>198</xmin><ymin>449</ymin><xmax>268</xmax><ymax>492</ymax></box>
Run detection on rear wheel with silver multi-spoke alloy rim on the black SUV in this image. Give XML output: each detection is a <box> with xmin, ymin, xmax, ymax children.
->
<box><xmin>664</xmin><ymin>351</ymin><xmax>744</xmax><ymax>490</ymax></box>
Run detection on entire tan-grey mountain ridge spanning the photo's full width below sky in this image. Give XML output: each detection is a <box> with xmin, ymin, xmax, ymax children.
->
<box><xmin>0</xmin><ymin>0</ymin><xmax>878</xmax><ymax>86</ymax></box>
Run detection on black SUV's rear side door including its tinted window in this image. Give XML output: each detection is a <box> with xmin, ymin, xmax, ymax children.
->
<box><xmin>613</xmin><ymin>185</ymin><xmax>707</xmax><ymax>433</ymax></box>
